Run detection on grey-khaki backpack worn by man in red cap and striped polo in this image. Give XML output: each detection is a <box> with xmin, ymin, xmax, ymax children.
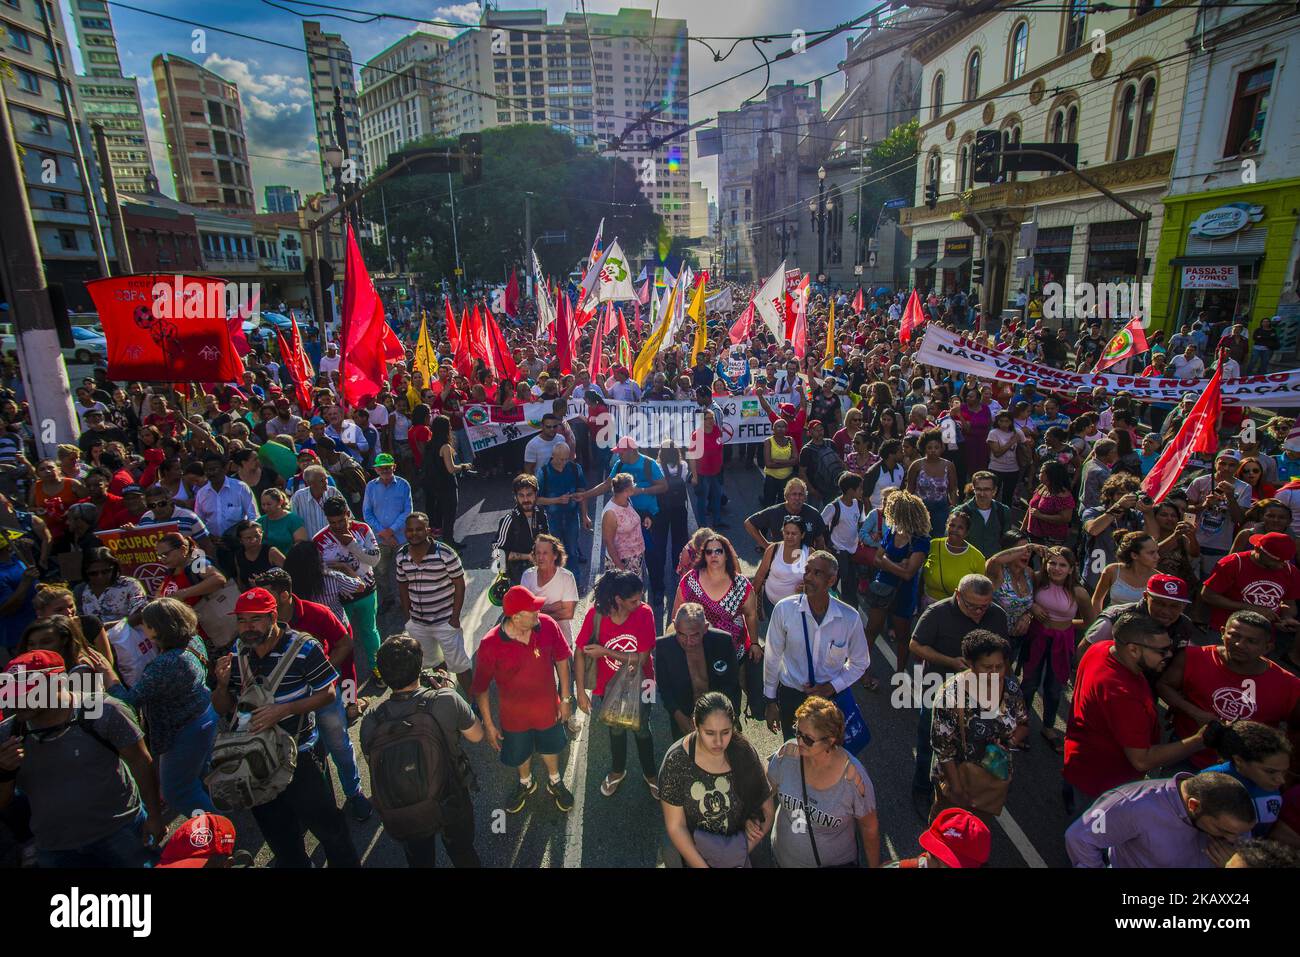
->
<box><xmin>203</xmin><ymin>632</ymin><xmax>309</xmax><ymax>811</ymax></box>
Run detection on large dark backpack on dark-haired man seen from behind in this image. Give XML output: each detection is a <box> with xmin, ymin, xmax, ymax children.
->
<box><xmin>365</xmin><ymin>687</ymin><xmax>464</xmax><ymax>841</ymax></box>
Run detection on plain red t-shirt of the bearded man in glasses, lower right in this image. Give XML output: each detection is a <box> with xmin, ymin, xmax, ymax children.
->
<box><xmin>1063</xmin><ymin>641</ymin><xmax>1160</xmax><ymax>794</ymax></box>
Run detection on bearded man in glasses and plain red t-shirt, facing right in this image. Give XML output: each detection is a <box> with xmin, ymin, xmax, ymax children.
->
<box><xmin>1062</xmin><ymin>611</ymin><xmax>1205</xmax><ymax>817</ymax></box>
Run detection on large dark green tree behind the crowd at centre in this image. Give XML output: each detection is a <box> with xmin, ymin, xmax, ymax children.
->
<box><xmin>364</xmin><ymin>124</ymin><xmax>660</xmax><ymax>295</ymax></box>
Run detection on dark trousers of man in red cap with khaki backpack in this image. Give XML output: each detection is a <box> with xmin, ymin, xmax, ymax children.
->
<box><xmin>252</xmin><ymin>748</ymin><xmax>361</xmax><ymax>867</ymax></box>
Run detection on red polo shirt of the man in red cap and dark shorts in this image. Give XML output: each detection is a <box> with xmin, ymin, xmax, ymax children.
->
<box><xmin>471</xmin><ymin>615</ymin><xmax>569</xmax><ymax>732</ymax></box>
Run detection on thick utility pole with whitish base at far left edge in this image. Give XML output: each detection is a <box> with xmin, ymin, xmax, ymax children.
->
<box><xmin>0</xmin><ymin>83</ymin><xmax>77</xmax><ymax>459</ymax></box>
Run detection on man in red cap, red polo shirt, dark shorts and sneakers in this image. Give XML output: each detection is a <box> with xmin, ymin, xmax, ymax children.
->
<box><xmin>471</xmin><ymin>585</ymin><xmax>573</xmax><ymax>814</ymax></box>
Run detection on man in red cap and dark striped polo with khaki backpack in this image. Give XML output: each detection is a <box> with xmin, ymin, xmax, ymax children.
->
<box><xmin>207</xmin><ymin>588</ymin><xmax>361</xmax><ymax>867</ymax></box>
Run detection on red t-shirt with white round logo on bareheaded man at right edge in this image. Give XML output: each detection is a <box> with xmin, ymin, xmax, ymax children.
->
<box><xmin>1174</xmin><ymin>645</ymin><xmax>1300</xmax><ymax>767</ymax></box>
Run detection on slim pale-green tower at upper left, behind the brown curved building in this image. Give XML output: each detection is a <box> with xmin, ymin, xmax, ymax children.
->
<box><xmin>72</xmin><ymin>0</ymin><xmax>153</xmax><ymax>192</ymax></box>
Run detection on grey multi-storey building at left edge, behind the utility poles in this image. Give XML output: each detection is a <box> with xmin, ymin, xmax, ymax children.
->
<box><xmin>0</xmin><ymin>0</ymin><xmax>114</xmax><ymax>309</ymax></box>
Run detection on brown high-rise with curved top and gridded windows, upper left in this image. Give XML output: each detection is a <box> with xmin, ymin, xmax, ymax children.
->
<box><xmin>153</xmin><ymin>53</ymin><xmax>255</xmax><ymax>213</ymax></box>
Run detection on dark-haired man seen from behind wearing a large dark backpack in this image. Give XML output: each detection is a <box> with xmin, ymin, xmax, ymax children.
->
<box><xmin>361</xmin><ymin>633</ymin><xmax>484</xmax><ymax>867</ymax></box>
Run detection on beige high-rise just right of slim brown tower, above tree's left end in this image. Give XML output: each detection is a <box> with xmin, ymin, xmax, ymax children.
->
<box><xmin>358</xmin><ymin>31</ymin><xmax>447</xmax><ymax>170</ymax></box>
